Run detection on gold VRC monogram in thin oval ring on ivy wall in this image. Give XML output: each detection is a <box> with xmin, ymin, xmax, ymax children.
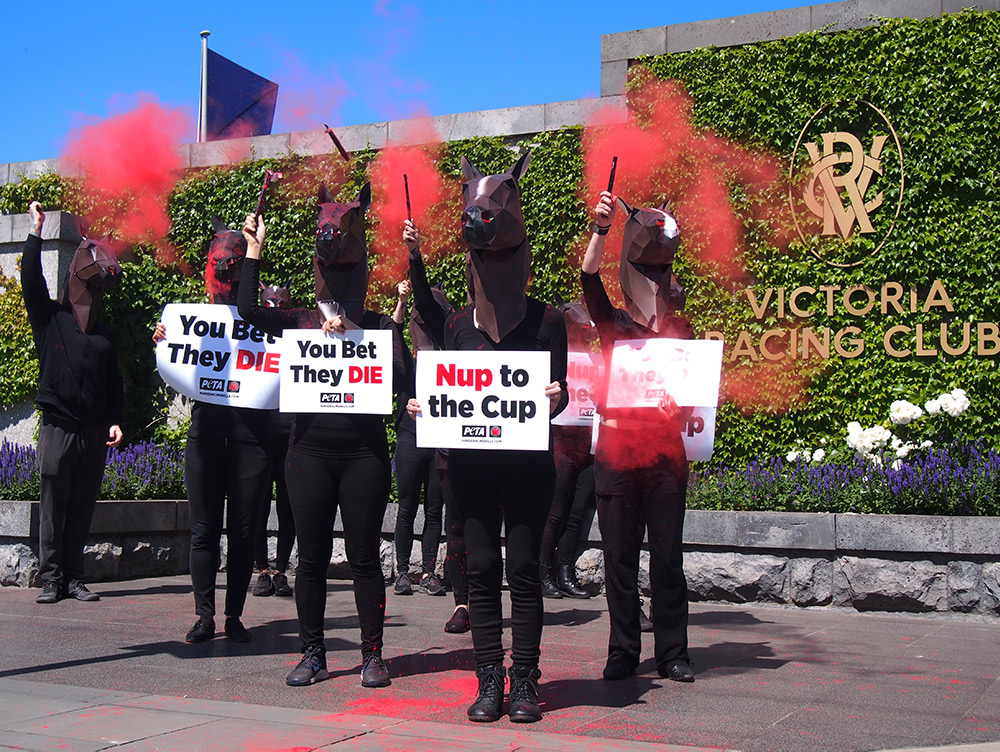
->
<box><xmin>789</xmin><ymin>101</ymin><xmax>903</xmax><ymax>267</ymax></box>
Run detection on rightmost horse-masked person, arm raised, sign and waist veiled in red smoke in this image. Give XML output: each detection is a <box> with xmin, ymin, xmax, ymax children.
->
<box><xmin>580</xmin><ymin>191</ymin><xmax>694</xmax><ymax>682</ymax></box>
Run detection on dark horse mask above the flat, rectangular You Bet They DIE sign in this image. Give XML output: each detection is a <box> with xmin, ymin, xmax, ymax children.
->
<box><xmin>313</xmin><ymin>183</ymin><xmax>372</xmax><ymax>324</ymax></box>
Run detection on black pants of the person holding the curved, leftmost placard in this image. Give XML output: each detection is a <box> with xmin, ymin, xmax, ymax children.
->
<box><xmin>184</xmin><ymin>436</ymin><xmax>271</xmax><ymax>616</ymax></box>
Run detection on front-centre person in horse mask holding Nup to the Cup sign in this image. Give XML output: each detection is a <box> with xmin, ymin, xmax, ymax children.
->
<box><xmin>407</xmin><ymin>153</ymin><xmax>567</xmax><ymax>723</ymax></box>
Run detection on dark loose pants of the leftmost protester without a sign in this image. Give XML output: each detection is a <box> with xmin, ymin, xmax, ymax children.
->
<box><xmin>38</xmin><ymin>418</ymin><xmax>108</xmax><ymax>586</ymax></box>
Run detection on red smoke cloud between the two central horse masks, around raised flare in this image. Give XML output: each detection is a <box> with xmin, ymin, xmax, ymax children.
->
<box><xmin>371</xmin><ymin>118</ymin><xmax>461</xmax><ymax>292</ymax></box>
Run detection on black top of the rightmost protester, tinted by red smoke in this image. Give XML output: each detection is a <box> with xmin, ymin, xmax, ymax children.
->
<box><xmin>580</xmin><ymin>272</ymin><xmax>694</xmax><ymax>438</ymax></box>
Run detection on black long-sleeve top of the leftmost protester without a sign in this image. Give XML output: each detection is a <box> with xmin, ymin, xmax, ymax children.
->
<box><xmin>21</xmin><ymin>235</ymin><xmax>125</xmax><ymax>428</ymax></box>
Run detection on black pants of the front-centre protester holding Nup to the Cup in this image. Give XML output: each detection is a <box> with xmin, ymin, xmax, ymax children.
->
<box><xmin>448</xmin><ymin>449</ymin><xmax>555</xmax><ymax>666</ymax></box>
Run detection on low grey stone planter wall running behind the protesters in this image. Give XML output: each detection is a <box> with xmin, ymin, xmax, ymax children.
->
<box><xmin>0</xmin><ymin>501</ymin><xmax>1000</xmax><ymax>617</ymax></box>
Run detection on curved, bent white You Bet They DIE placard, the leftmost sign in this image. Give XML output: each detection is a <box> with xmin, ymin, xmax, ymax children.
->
<box><xmin>156</xmin><ymin>303</ymin><xmax>281</xmax><ymax>410</ymax></box>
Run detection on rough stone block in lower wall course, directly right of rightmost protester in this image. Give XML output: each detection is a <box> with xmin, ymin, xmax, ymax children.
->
<box><xmin>684</xmin><ymin>551</ymin><xmax>788</xmax><ymax>603</ymax></box>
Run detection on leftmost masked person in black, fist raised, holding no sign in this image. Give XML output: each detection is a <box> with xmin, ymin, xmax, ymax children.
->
<box><xmin>21</xmin><ymin>201</ymin><xmax>124</xmax><ymax>603</ymax></box>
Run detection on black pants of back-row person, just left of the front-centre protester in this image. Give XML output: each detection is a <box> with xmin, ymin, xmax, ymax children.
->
<box><xmin>393</xmin><ymin>431</ymin><xmax>444</xmax><ymax>574</ymax></box>
